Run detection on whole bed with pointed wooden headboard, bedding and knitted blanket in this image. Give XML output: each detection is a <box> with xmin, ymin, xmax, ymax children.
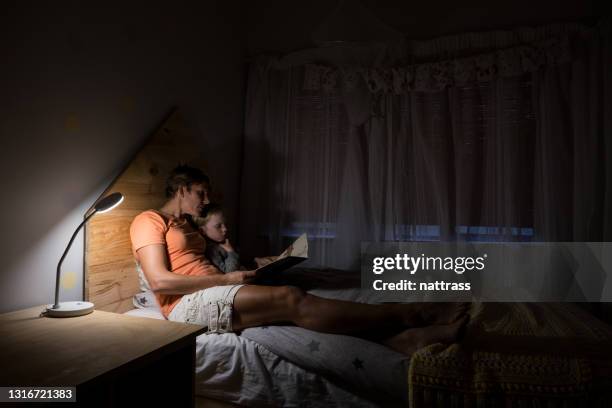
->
<box><xmin>84</xmin><ymin>111</ymin><xmax>612</xmax><ymax>407</ymax></box>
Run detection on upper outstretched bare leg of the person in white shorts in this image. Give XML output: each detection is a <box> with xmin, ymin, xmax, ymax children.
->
<box><xmin>233</xmin><ymin>285</ymin><xmax>466</xmax><ymax>333</ymax></box>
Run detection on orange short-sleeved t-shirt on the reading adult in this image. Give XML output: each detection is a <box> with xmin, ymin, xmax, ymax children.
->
<box><xmin>130</xmin><ymin>210</ymin><xmax>221</xmax><ymax>317</ymax></box>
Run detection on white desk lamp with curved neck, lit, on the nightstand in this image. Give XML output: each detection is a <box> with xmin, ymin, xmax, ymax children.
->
<box><xmin>43</xmin><ymin>193</ymin><xmax>123</xmax><ymax>317</ymax></box>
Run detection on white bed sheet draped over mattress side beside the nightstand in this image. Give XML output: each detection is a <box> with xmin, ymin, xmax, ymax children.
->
<box><xmin>125</xmin><ymin>308</ymin><xmax>377</xmax><ymax>407</ymax></box>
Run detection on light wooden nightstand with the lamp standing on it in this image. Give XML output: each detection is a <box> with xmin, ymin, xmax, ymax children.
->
<box><xmin>0</xmin><ymin>306</ymin><xmax>204</xmax><ymax>407</ymax></box>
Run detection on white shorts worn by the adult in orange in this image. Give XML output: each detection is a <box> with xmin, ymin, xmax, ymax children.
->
<box><xmin>168</xmin><ymin>285</ymin><xmax>244</xmax><ymax>333</ymax></box>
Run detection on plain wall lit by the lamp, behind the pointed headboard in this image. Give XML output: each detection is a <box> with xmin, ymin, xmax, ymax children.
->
<box><xmin>0</xmin><ymin>1</ymin><xmax>245</xmax><ymax>312</ymax></box>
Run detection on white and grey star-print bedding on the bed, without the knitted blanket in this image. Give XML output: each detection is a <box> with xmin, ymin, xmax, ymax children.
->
<box><xmin>126</xmin><ymin>276</ymin><xmax>408</xmax><ymax>407</ymax></box>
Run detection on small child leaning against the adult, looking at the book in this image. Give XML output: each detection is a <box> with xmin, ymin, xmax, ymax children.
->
<box><xmin>194</xmin><ymin>204</ymin><xmax>243</xmax><ymax>272</ymax></box>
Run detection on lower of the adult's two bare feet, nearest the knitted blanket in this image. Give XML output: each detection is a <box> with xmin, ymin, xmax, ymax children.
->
<box><xmin>383</xmin><ymin>314</ymin><xmax>468</xmax><ymax>356</ymax></box>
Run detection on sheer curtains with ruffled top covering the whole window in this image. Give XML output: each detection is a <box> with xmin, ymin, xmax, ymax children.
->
<box><xmin>239</xmin><ymin>21</ymin><xmax>612</xmax><ymax>269</ymax></box>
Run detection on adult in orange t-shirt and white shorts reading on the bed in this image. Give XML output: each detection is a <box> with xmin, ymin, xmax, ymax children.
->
<box><xmin>130</xmin><ymin>166</ymin><xmax>467</xmax><ymax>355</ymax></box>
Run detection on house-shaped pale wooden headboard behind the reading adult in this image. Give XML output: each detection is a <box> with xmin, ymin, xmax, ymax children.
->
<box><xmin>83</xmin><ymin>111</ymin><xmax>206</xmax><ymax>313</ymax></box>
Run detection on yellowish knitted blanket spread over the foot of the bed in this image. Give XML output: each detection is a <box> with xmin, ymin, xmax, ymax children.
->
<box><xmin>408</xmin><ymin>303</ymin><xmax>612</xmax><ymax>408</ymax></box>
